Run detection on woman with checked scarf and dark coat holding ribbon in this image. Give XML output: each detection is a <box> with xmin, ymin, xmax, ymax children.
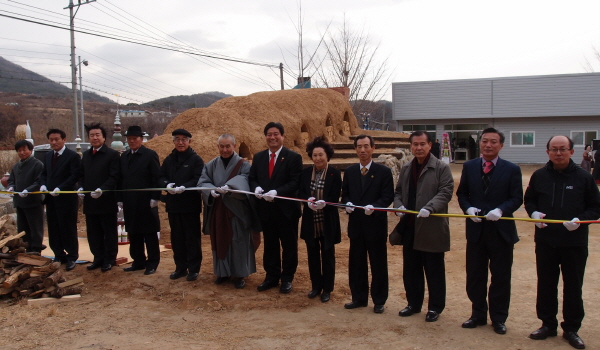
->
<box><xmin>298</xmin><ymin>137</ymin><xmax>342</xmax><ymax>303</ymax></box>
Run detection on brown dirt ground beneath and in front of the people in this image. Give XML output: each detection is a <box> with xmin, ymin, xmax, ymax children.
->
<box><xmin>0</xmin><ymin>165</ymin><xmax>600</xmax><ymax>349</ymax></box>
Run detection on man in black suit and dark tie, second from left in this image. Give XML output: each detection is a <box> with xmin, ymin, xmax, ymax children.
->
<box><xmin>40</xmin><ymin>129</ymin><xmax>81</xmax><ymax>271</ymax></box>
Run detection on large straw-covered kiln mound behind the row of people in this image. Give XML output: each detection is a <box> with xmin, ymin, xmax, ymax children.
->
<box><xmin>146</xmin><ymin>89</ymin><xmax>361</xmax><ymax>162</ymax></box>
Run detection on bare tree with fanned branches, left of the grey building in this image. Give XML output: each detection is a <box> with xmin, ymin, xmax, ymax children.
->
<box><xmin>317</xmin><ymin>16</ymin><xmax>391</xmax><ymax>116</ymax></box>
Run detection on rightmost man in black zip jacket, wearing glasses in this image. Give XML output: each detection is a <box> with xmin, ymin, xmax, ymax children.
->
<box><xmin>525</xmin><ymin>136</ymin><xmax>600</xmax><ymax>349</ymax></box>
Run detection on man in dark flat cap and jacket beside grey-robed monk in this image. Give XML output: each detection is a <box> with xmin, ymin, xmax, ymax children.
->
<box><xmin>160</xmin><ymin>129</ymin><xmax>204</xmax><ymax>281</ymax></box>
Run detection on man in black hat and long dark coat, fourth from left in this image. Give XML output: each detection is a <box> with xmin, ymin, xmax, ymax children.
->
<box><xmin>119</xmin><ymin>125</ymin><xmax>160</xmax><ymax>275</ymax></box>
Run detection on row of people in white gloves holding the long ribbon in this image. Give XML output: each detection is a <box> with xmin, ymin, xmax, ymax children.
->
<box><xmin>9</xmin><ymin>122</ymin><xmax>600</xmax><ymax>347</ymax></box>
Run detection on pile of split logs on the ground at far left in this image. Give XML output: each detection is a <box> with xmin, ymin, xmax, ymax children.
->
<box><xmin>0</xmin><ymin>216</ymin><xmax>83</xmax><ymax>299</ymax></box>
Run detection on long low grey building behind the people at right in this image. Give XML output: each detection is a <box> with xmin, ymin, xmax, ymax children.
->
<box><xmin>392</xmin><ymin>73</ymin><xmax>600</xmax><ymax>163</ymax></box>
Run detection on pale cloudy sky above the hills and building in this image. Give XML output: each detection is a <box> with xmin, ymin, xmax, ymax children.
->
<box><xmin>0</xmin><ymin>0</ymin><xmax>600</xmax><ymax>103</ymax></box>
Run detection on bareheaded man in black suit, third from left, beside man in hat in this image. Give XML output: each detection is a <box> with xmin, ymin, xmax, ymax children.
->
<box><xmin>79</xmin><ymin>123</ymin><xmax>120</xmax><ymax>272</ymax></box>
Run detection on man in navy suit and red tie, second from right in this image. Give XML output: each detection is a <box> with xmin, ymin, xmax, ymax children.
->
<box><xmin>456</xmin><ymin>128</ymin><xmax>523</xmax><ymax>334</ymax></box>
